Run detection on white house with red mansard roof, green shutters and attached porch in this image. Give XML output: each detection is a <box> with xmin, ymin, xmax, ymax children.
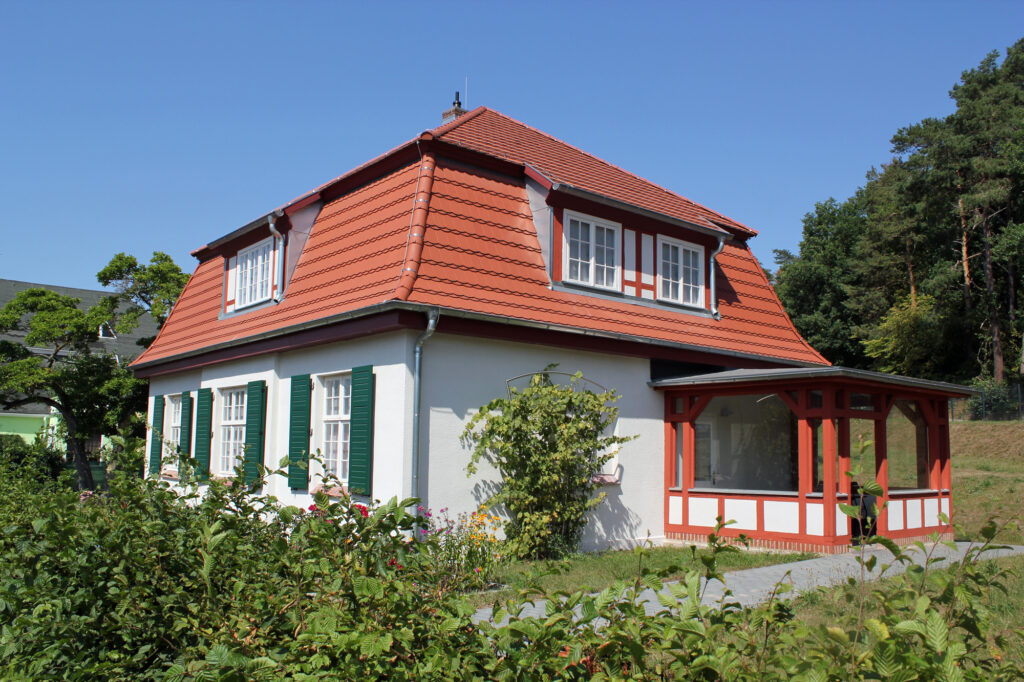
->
<box><xmin>133</xmin><ymin>106</ymin><xmax>966</xmax><ymax>551</ymax></box>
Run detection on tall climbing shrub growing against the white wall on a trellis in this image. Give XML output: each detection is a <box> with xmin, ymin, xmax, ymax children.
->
<box><xmin>462</xmin><ymin>367</ymin><xmax>631</xmax><ymax>558</ymax></box>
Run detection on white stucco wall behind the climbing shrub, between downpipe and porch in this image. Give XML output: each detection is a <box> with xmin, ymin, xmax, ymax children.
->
<box><xmin>421</xmin><ymin>334</ymin><xmax>665</xmax><ymax>550</ymax></box>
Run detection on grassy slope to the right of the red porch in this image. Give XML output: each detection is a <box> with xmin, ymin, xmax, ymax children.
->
<box><xmin>949</xmin><ymin>422</ymin><xmax>1024</xmax><ymax>544</ymax></box>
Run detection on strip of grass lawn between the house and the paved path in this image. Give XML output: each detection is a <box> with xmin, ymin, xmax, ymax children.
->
<box><xmin>470</xmin><ymin>547</ymin><xmax>817</xmax><ymax>606</ymax></box>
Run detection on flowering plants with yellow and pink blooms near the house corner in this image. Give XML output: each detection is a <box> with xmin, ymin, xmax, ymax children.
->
<box><xmin>416</xmin><ymin>507</ymin><xmax>505</xmax><ymax>589</ymax></box>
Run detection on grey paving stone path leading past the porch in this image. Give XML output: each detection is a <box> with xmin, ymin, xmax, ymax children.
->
<box><xmin>473</xmin><ymin>543</ymin><xmax>1024</xmax><ymax>622</ymax></box>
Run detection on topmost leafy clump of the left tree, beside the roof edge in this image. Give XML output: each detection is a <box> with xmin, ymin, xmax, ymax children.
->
<box><xmin>96</xmin><ymin>251</ymin><xmax>188</xmax><ymax>346</ymax></box>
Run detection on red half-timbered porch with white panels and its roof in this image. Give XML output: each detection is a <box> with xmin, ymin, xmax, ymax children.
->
<box><xmin>651</xmin><ymin>367</ymin><xmax>971</xmax><ymax>552</ymax></box>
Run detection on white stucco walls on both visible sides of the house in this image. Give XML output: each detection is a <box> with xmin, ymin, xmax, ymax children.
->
<box><xmin>146</xmin><ymin>332</ymin><xmax>665</xmax><ymax>550</ymax></box>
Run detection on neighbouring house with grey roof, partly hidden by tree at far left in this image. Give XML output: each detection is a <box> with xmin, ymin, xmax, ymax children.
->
<box><xmin>0</xmin><ymin>280</ymin><xmax>157</xmax><ymax>446</ymax></box>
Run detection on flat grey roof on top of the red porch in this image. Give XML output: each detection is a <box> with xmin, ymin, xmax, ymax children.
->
<box><xmin>648</xmin><ymin>366</ymin><xmax>980</xmax><ymax>396</ymax></box>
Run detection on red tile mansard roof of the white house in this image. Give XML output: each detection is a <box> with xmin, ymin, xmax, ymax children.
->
<box><xmin>135</xmin><ymin>109</ymin><xmax>827</xmax><ymax>366</ymax></box>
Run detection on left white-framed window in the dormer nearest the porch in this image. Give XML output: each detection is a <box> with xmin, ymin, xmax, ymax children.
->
<box><xmin>562</xmin><ymin>211</ymin><xmax>622</xmax><ymax>291</ymax></box>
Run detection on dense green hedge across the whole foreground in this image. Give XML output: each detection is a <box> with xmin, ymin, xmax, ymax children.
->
<box><xmin>0</xmin><ymin>444</ymin><xmax>1024</xmax><ymax>680</ymax></box>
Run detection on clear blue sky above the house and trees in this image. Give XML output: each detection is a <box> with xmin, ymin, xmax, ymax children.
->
<box><xmin>0</xmin><ymin>0</ymin><xmax>1024</xmax><ymax>288</ymax></box>
